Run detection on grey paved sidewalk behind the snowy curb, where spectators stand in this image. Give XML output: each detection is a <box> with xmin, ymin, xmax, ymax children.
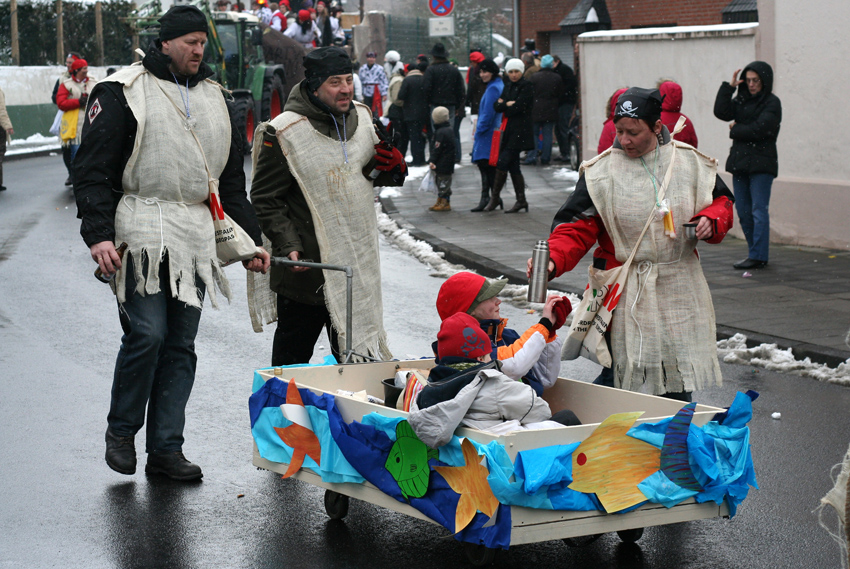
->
<box><xmin>381</xmin><ymin>159</ymin><xmax>850</xmax><ymax>367</ymax></box>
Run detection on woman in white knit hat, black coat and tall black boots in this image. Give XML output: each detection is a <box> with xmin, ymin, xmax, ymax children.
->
<box><xmin>484</xmin><ymin>59</ymin><xmax>534</xmax><ymax>213</ymax></box>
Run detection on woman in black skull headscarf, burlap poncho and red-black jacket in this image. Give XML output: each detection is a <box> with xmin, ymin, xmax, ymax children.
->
<box><xmin>529</xmin><ymin>87</ymin><xmax>734</xmax><ymax>401</ymax></box>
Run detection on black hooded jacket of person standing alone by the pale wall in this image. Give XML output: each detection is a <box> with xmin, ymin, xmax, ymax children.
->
<box><xmin>714</xmin><ymin>61</ymin><xmax>782</xmax><ymax>176</ymax></box>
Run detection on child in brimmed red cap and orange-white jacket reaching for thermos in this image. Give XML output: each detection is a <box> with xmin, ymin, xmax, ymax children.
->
<box><xmin>434</xmin><ymin>271</ymin><xmax>572</xmax><ymax>395</ymax></box>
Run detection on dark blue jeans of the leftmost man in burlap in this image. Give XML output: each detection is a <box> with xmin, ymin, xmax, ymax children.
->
<box><xmin>107</xmin><ymin>256</ymin><xmax>205</xmax><ymax>453</ymax></box>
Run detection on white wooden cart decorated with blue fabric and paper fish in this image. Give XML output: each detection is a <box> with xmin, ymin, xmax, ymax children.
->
<box><xmin>251</xmin><ymin>360</ymin><xmax>755</xmax><ymax>565</ymax></box>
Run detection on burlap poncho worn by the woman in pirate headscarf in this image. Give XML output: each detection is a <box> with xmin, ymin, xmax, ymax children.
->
<box><xmin>582</xmin><ymin>141</ymin><xmax>722</xmax><ymax>395</ymax></box>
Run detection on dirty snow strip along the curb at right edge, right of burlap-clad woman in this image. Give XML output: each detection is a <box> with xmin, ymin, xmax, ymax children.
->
<box><xmin>717</xmin><ymin>334</ymin><xmax>850</xmax><ymax>386</ymax></box>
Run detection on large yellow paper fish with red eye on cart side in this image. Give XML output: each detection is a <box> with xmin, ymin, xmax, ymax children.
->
<box><xmin>569</xmin><ymin>412</ymin><xmax>661</xmax><ymax>513</ymax></box>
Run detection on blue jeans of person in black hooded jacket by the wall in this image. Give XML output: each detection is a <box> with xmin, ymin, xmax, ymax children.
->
<box><xmin>732</xmin><ymin>174</ymin><xmax>773</xmax><ymax>262</ymax></box>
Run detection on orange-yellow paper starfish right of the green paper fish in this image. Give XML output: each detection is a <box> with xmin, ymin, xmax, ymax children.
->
<box><xmin>434</xmin><ymin>439</ymin><xmax>499</xmax><ymax>533</ymax></box>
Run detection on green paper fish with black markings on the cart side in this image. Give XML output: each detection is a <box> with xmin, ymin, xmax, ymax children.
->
<box><xmin>384</xmin><ymin>421</ymin><xmax>440</xmax><ymax>499</ymax></box>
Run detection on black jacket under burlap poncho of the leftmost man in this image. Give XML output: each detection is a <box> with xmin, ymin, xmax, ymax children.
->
<box><xmin>74</xmin><ymin>43</ymin><xmax>263</xmax><ymax>247</ymax></box>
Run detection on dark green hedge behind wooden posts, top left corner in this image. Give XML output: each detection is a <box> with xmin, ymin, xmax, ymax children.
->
<box><xmin>0</xmin><ymin>0</ymin><xmax>133</xmax><ymax>65</ymax></box>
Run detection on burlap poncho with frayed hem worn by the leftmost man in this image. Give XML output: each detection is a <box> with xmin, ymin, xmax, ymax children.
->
<box><xmin>100</xmin><ymin>64</ymin><xmax>230</xmax><ymax>308</ymax></box>
